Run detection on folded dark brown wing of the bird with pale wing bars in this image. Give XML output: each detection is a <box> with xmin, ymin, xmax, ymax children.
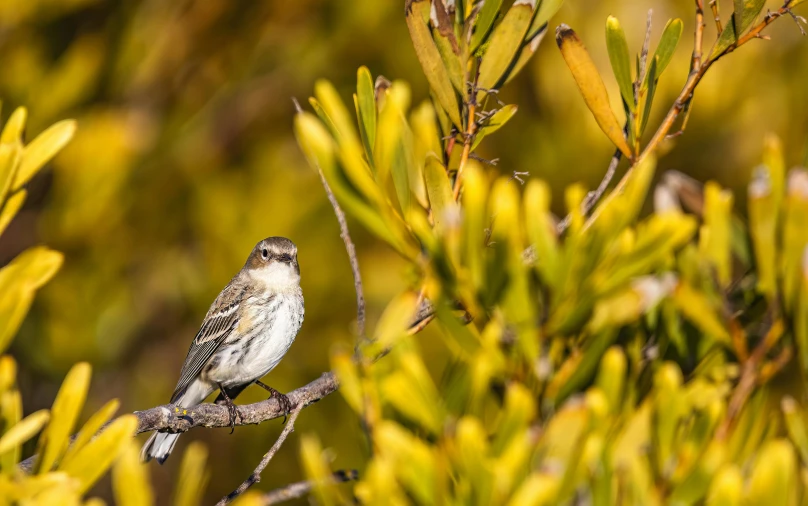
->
<box><xmin>171</xmin><ymin>286</ymin><xmax>245</xmax><ymax>403</ymax></box>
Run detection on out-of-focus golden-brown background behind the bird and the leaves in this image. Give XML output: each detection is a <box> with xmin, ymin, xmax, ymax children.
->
<box><xmin>0</xmin><ymin>0</ymin><xmax>808</xmax><ymax>504</ymax></box>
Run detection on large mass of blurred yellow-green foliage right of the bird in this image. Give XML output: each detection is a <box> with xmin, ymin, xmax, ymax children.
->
<box><xmin>295</xmin><ymin>59</ymin><xmax>808</xmax><ymax>505</ymax></box>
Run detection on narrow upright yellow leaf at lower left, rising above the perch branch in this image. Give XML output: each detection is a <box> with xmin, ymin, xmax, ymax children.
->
<box><xmin>36</xmin><ymin>362</ymin><xmax>91</xmax><ymax>473</ymax></box>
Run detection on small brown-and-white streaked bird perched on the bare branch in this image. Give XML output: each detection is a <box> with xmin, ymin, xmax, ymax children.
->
<box><xmin>140</xmin><ymin>237</ymin><xmax>304</xmax><ymax>464</ymax></box>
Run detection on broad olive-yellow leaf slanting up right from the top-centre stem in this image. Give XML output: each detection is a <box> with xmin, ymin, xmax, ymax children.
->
<box><xmin>477</xmin><ymin>0</ymin><xmax>533</xmax><ymax>88</ymax></box>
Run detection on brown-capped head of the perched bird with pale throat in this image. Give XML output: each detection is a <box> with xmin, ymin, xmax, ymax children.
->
<box><xmin>244</xmin><ymin>237</ymin><xmax>300</xmax><ymax>292</ymax></box>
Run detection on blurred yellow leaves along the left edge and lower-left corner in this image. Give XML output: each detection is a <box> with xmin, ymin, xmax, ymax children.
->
<box><xmin>0</xmin><ymin>108</ymin><xmax>211</xmax><ymax>506</ymax></box>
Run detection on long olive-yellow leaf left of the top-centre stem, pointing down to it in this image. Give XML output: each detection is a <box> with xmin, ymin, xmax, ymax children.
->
<box><xmin>406</xmin><ymin>0</ymin><xmax>463</xmax><ymax>129</ymax></box>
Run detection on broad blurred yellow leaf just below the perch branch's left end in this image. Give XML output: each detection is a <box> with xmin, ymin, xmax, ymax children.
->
<box><xmin>59</xmin><ymin>415</ymin><xmax>137</xmax><ymax>492</ymax></box>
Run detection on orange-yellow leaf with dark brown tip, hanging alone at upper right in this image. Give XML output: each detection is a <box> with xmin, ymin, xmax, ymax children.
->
<box><xmin>556</xmin><ymin>25</ymin><xmax>633</xmax><ymax>158</ymax></box>
